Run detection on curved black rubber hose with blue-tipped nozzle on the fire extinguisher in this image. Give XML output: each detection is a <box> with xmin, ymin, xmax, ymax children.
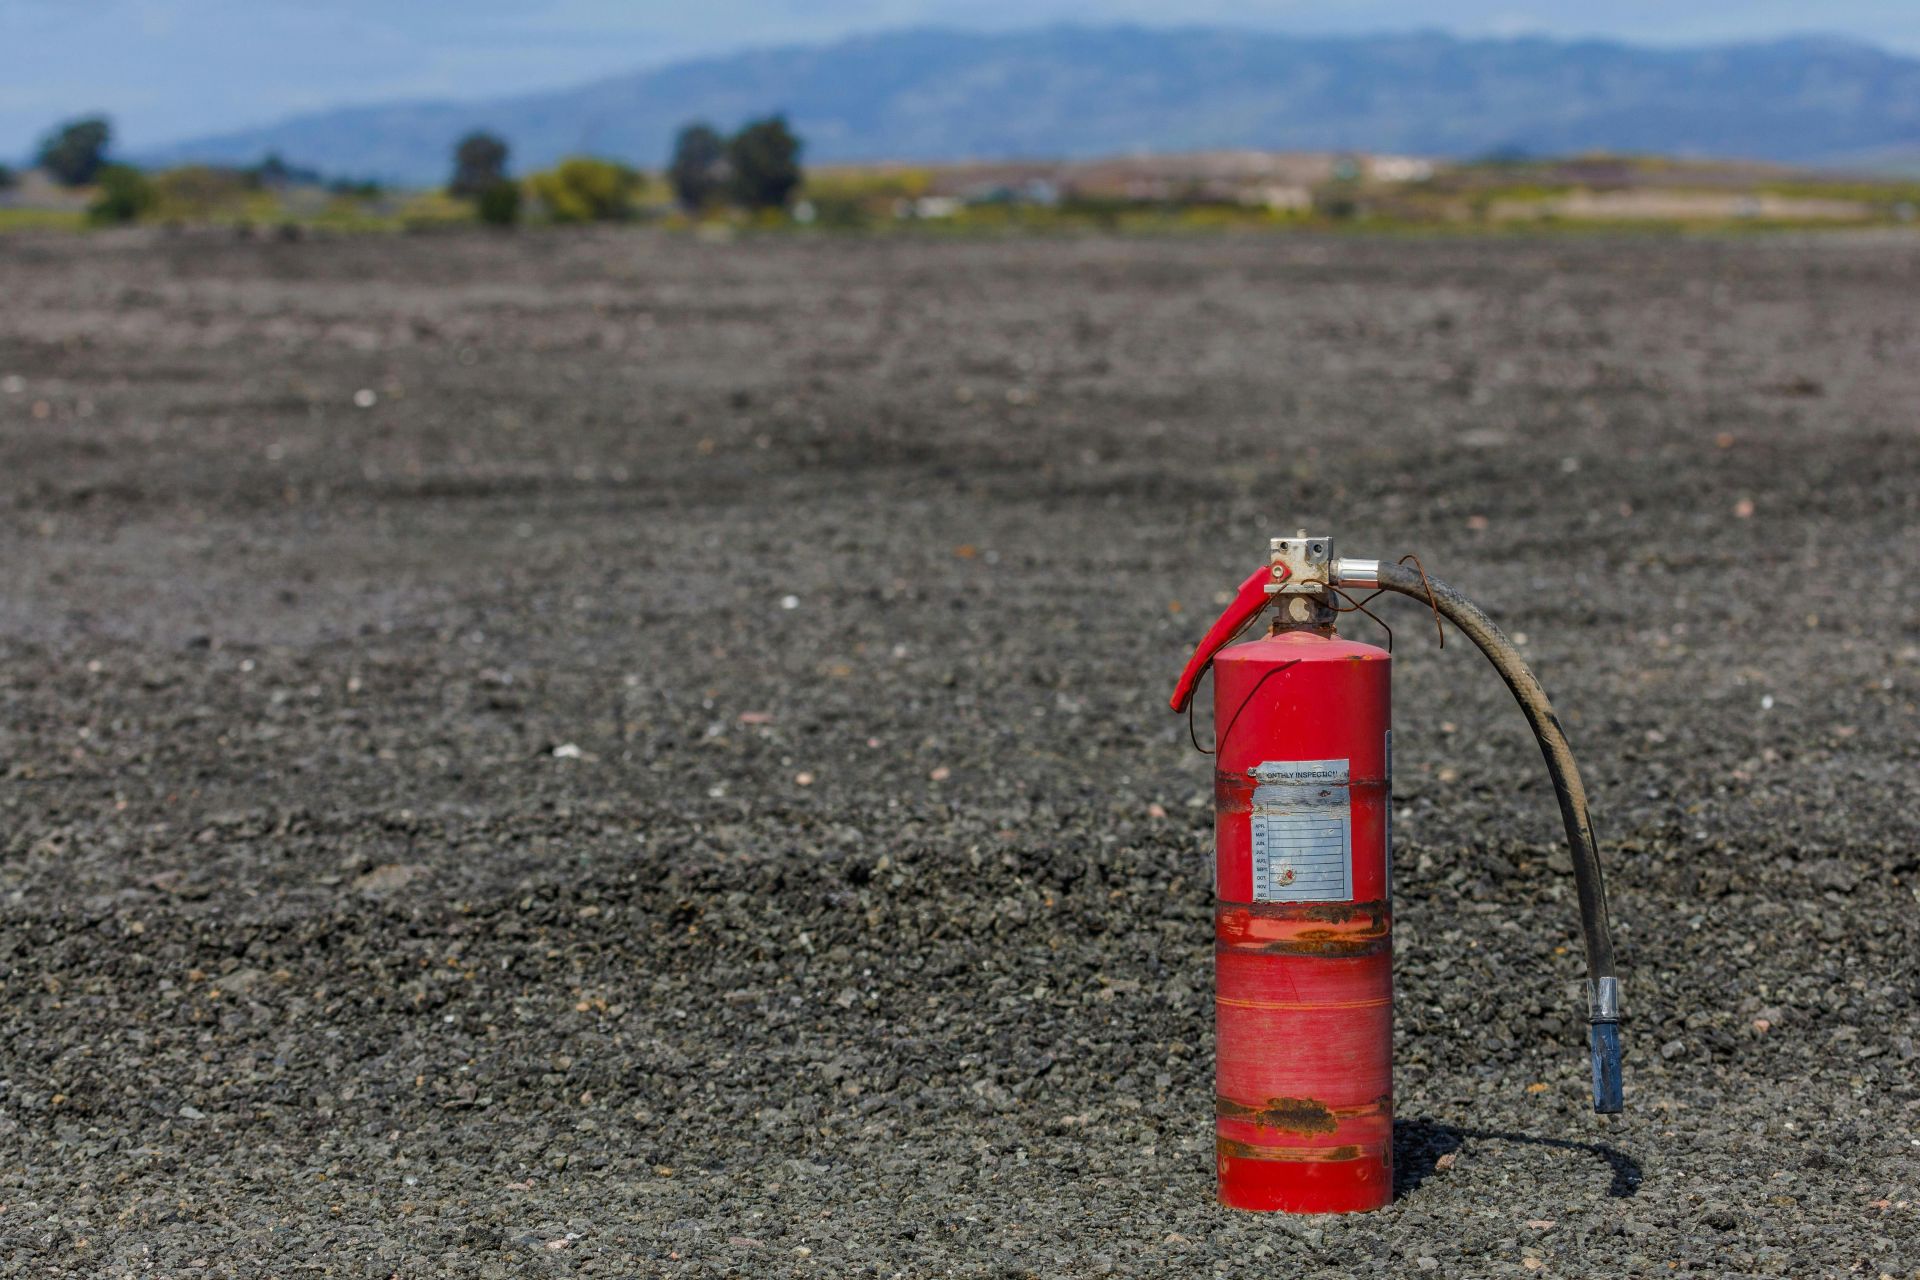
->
<box><xmin>1377</xmin><ymin>562</ymin><xmax>1620</xmax><ymax>1113</ymax></box>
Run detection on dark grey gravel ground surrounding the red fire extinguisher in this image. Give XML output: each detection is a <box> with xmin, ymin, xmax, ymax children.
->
<box><xmin>0</xmin><ymin>232</ymin><xmax>1920</xmax><ymax>1276</ymax></box>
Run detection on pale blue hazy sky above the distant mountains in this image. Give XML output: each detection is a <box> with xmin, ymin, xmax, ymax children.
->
<box><xmin>0</xmin><ymin>0</ymin><xmax>1920</xmax><ymax>157</ymax></box>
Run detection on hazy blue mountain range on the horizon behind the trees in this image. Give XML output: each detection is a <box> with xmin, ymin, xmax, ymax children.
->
<box><xmin>140</xmin><ymin>27</ymin><xmax>1920</xmax><ymax>182</ymax></box>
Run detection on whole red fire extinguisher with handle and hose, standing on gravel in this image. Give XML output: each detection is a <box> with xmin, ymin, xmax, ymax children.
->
<box><xmin>1171</xmin><ymin>532</ymin><xmax>1622</xmax><ymax>1213</ymax></box>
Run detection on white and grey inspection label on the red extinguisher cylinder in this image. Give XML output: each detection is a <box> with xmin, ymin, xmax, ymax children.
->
<box><xmin>1254</xmin><ymin>760</ymin><xmax>1354</xmax><ymax>902</ymax></box>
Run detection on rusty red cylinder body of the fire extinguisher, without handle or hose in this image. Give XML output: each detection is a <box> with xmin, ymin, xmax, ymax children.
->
<box><xmin>1213</xmin><ymin>629</ymin><xmax>1394</xmax><ymax>1213</ymax></box>
